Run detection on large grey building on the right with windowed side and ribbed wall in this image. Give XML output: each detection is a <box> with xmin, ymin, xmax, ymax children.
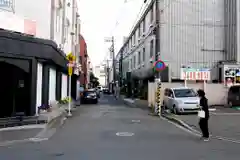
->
<box><xmin>118</xmin><ymin>0</ymin><xmax>225</xmax><ymax>81</ymax></box>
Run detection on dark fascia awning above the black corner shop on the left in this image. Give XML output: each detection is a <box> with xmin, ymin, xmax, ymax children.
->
<box><xmin>0</xmin><ymin>30</ymin><xmax>67</xmax><ymax>68</ymax></box>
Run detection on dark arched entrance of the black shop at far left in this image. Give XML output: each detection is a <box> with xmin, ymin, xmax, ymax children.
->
<box><xmin>0</xmin><ymin>62</ymin><xmax>30</xmax><ymax>117</ymax></box>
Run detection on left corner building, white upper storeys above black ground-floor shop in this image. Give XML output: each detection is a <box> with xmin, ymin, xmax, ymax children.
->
<box><xmin>0</xmin><ymin>0</ymin><xmax>80</xmax><ymax>116</ymax></box>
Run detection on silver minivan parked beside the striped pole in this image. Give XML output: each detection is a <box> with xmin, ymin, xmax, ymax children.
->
<box><xmin>163</xmin><ymin>87</ymin><xmax>200</xmax><ymax>114</ymax></box>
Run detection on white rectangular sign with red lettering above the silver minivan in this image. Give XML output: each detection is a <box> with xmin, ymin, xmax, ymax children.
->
<box><xmin>181</xmin><ymin>68</ymin><xmax>211</xmax><ymax>81</ymax></box>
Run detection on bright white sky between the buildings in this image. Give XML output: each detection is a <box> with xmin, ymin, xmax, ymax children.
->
<box><xmin>79</xmin><ymin>0</ymin><xmax>143</xmax><ymax>66</ymax></box>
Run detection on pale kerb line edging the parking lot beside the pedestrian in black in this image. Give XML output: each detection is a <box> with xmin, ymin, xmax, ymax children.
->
<box><xmin>160</xmin><ymin>117</ymin><xmax>240</xmax><ymax>144</ymax></box>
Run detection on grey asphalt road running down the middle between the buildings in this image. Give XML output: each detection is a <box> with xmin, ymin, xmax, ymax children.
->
<box><xmin>0</xmin><ymin>96</ymin><xmax>240</xmax><ymax>160</ymax></box>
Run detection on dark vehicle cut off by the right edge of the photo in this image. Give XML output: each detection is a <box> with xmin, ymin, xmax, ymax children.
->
<box><xmin>227</xmin><ymin>85</ymin><xmax>240</xmax><ymax>107</ymax></box>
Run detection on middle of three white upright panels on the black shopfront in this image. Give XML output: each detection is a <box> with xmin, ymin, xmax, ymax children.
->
<box><xmin>48</xmin><ymin>68</ymin><xmax>56</xmax><ymax>102</ymax></box>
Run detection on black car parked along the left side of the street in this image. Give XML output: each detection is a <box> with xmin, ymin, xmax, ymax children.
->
<box><xmin>81</xmin><ymin>90</ymin><xmax>98</xmax><ymax>104</ymax></box>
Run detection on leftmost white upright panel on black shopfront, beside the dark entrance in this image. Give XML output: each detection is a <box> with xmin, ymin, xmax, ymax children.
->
<box><xmin>36</xmin><ymin>63</ymin><xmax>43</xmax><ymax>114</ymax></box>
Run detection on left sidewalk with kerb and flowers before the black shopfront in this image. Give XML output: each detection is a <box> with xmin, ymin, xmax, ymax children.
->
<box><xmin>0</xmin><ymin>102</ymin><xmax>80</xmax><ymax>146</ymax></box>
